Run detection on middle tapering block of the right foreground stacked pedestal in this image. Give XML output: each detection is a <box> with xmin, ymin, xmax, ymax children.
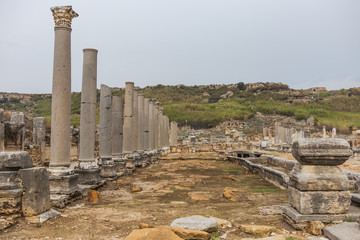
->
<box><xmin>289</xmin><ymin>164</ymin><xmax>349</xmax><ymax>191</ymax></box>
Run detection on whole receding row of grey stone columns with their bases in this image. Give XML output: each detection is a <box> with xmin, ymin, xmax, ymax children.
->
<box><xmin>44</xmin><ymin>6</ymin><xmax>177</xmax><ymax>199</ymax></box>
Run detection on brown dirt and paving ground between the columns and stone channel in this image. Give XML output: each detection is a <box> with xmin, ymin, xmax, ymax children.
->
<box><xmin>0</xmin><ymin>155</ymin><xmax>308</xmax><ymax>240</ymax></box>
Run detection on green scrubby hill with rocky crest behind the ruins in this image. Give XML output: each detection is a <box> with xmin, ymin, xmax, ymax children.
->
<box><xmin>0</xmin><ymin>83</ymin><xmax>360</xmax><ymax>130</ymax></box>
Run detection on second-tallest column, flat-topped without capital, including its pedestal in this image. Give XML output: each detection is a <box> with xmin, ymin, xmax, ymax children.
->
<box><xmin>75</xmin><ymin>48</ymin><xmax>100</xmax><ymax>185</ymax></box>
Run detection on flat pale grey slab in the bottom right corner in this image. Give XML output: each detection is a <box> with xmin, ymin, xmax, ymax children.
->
<box><xmin>324</xmin><ymin>222</ymin><xmax>360</xmax><ymax>240</ymax></box>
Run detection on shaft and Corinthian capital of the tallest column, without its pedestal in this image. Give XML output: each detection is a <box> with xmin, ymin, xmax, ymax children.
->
<box><xmin>50</xmin><ymin>6</ymin><xmax>78</xmax><ymax>168</ymax></box>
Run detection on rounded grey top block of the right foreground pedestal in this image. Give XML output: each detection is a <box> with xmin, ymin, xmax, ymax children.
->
<box><xmin>292</xmin><ymin>138</ymin><xmax>352</xmax><ymax>166</ymax></box>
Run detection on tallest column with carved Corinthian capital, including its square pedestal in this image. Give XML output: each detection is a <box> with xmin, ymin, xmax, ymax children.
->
<box><xmin>48</xmin><ymin>6</ymin><xmax>79</xmax><ymax>197</ymax></box>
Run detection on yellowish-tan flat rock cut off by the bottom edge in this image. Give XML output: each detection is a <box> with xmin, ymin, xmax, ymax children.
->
<box><xmin>125</xmin><ymin>228</ymin><xmax>183</xmax><ymax>240</ymax></box>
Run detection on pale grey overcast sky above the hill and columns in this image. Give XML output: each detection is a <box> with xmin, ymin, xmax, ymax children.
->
<box><xmin>0</xmin><ymin>0</ymin><xmax>360</xmax><ymax>93</ymax></box>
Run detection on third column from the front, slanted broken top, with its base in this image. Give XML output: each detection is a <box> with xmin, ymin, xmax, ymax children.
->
<box><xmin>99</xmin><ymin>84</ymin><xmax>116</xmax><ymax>178</ymax></box>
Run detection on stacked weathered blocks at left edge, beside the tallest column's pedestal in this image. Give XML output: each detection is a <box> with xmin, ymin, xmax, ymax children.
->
<box><xmin>0</xmin><ymin>151</ymin><xmax>54</xmax><ymax>230</ymax></box>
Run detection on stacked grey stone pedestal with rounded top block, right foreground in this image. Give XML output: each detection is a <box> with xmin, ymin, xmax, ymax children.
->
<box><xmin>285</xmin><ymin>138</ymin><xmax>352</xmax><ymax>228</ymax></box>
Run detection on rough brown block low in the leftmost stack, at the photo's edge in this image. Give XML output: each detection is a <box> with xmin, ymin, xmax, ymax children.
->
<box><xmin>0</xmin><ymin>189</ymin><xmax>23</xmax><ymax>214</ymax></box>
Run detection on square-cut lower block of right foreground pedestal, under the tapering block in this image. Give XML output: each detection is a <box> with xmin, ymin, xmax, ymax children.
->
<box><xmin>288</xmin><ymin>187</ymin><xmax>351</xmax><ymax>214</ymax></box>
